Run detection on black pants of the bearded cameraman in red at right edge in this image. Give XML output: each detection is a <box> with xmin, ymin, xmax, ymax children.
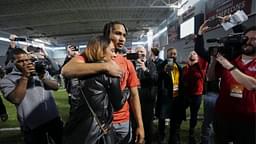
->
<box><xmin>213</xmin><ymin>114</ymin><xmax>256</xmax><ymax>144</ymax></box>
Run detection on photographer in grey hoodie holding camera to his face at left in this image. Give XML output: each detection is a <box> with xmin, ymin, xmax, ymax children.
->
<box><xmin>0</xmin><ymin>48</ymin><xmax>63</xmax><ymax>144</ymax></box>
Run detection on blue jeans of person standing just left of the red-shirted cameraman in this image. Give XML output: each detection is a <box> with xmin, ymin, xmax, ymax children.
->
<box><xmin>201</xmin><ymin>92</ymin><xmax>219</xmax><ymax>144</ymax></box>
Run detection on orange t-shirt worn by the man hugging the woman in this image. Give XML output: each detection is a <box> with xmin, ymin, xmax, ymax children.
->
<box><xmin>78</xmin><ymin>54</ymin><xmax>140</xmax><ymax>123</ymax></box>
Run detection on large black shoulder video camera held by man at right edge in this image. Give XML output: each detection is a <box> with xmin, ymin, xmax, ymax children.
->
<box><xmin>206</xmin><ymin>33</ymin><xmax>248</xmax><ymax>60</ymax></box>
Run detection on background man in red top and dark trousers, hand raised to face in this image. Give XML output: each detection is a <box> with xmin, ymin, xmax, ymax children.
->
<box><xmin>183</xmin><ymin>44</ymin><xmax>208</xmax><ymax>144</ymax></box>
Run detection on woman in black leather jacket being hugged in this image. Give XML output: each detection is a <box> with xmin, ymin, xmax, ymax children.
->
<box><xmin>64</xmin><ymin>36</ymin><xmax>125</xmax><ymax>144</ymax></box>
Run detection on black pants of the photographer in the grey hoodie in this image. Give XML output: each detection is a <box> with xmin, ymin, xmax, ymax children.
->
<box><xmin>23</xmin><ymin>117</ymin><xmax>63</xmax><ymax>144</ymax></box>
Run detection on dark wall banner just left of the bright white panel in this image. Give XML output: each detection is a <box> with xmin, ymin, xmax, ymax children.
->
<box><xmin>167</xmin><ymin>23</ymin><xmax>180</xmax><ymax>44</ymax></box>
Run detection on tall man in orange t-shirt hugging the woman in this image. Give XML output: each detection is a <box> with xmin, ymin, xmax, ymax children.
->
<box><xmin>62</xmin><ymin>21</ymin><xmax>144</xmax><ymax>143</ymax></box>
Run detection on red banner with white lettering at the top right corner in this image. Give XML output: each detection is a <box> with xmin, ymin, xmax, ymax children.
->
<box><xmin>205</xmin><ymin>0</ymin><xmax>252</xmax><ymax>19</ymax></box>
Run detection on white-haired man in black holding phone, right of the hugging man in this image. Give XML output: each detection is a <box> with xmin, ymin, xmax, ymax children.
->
<box><xmin>134</xmin><ymin>46</ymin><xmax>158</xmax><ymax>144</ymax></box>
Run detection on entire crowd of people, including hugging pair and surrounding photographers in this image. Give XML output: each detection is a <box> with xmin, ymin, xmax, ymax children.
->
<box><xmin>0</xmin><ymin>13</ymin><xmax>256</xmax><ymax>144</ymax></box>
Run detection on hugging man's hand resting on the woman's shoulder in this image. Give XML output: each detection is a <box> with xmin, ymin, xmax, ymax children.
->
<box><xmin>106</xmin><ymin>60</ymin><xmax>123</xmax><ymax>77</ymax></box>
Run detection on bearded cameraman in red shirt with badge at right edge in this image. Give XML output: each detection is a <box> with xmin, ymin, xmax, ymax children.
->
<box><xmin>209</xmin><ymin>27</ymin><xmax>256</xmax><ymax>144</ymax></box>
